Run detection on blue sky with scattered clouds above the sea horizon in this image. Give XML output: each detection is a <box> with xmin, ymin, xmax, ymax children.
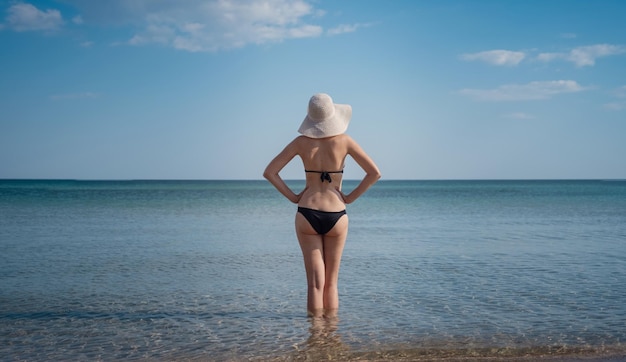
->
<box><xmin>0</xmin><ymin>0</ymin><xmax>626</xmax><ymax>179</ymax></box>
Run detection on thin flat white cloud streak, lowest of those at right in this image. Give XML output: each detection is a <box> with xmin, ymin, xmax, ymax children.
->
<box><xmin>459</xmin><ymin>80</ymin><xmax>585</xmax><ymax>101</ymax></box>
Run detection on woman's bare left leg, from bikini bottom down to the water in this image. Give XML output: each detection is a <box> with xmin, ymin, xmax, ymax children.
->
<box><xmin>296</xmin><ymin>213</ymin><xmax>326</xmax><ymax>317</ymax></box>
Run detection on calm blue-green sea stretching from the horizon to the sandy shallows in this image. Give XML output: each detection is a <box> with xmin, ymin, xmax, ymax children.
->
<box><xmin>0</xmin><ymin>180</ymin><xmax>626</xmax><ymax>361</ymax></box>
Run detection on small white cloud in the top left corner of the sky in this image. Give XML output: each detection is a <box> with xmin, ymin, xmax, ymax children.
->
<box><xmin>4</xmin><ymin>3</ymin><xmax>63</xmax><ymax>31</ymax></box>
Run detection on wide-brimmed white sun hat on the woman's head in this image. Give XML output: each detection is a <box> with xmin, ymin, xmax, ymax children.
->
<box><xmin>298</xmin><ymin>93</ymin><xmax>352</xmax><ymax>138</ymax></box>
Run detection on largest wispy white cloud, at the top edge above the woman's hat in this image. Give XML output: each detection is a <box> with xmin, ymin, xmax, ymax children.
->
<box><xmin>67</xmin><ymin>0</ymin><xmax>334</xmax><ymax>52</ymax></box>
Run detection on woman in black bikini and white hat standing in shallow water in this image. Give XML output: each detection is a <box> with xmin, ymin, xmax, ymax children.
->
<box><xmin>263</xmin><ymin>93</ymin><xmax>380</xmax><ymax>317</ymax></box>
